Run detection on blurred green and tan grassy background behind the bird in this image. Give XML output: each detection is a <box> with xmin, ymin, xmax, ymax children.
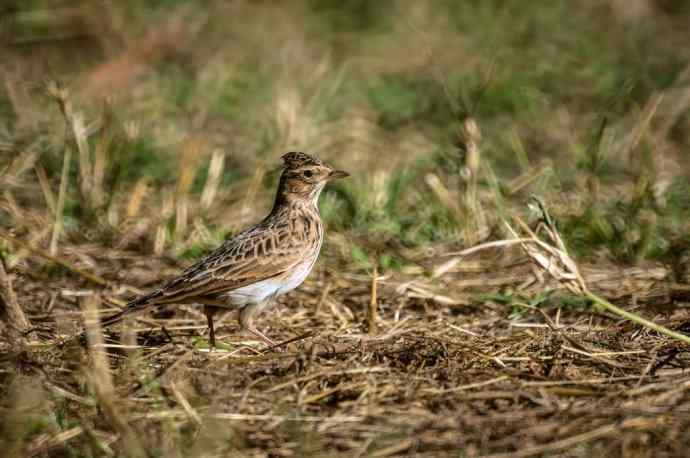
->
<box><xmin>0</xmin><ymin>0</ymin><xmax>690</xmax><ymax>267</ymax></box>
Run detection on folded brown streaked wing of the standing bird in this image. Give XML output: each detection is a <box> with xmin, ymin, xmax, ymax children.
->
<box><xmin>152</xmin><ymin>221</ymin><xmax>305</xmax><ymax>304</ymax></box>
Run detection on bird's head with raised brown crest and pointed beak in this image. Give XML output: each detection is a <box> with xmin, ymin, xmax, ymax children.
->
<box><xmin>278</xmin><ymin>152</ymin><xmax>350</xmax><ymax>204</ymax></box>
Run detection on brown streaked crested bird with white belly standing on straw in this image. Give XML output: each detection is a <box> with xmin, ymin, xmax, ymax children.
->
<box><xmin>101</xmin><ymin>151</ymin><xmax>349</xmax><ymax>349</ymax></box>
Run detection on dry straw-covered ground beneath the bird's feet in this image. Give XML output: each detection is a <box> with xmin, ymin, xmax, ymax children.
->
<box><xmin>2</xmin><ymin>247</ymin><xmax>690</xmax><ymax>457</ymax></box>
